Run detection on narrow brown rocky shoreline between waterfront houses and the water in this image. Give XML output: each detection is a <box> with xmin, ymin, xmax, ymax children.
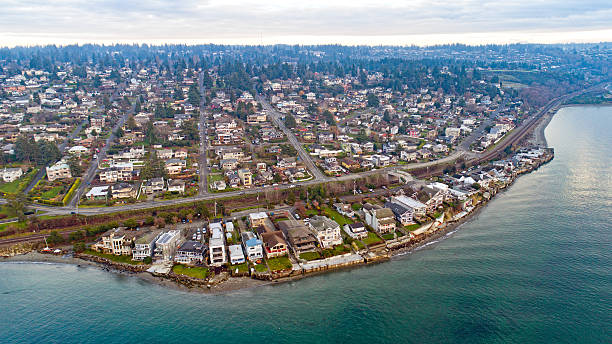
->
<box><xmin>0</xmin><ymin>114</ymin><xmax>554</xmax><ymax>294</ymax></box>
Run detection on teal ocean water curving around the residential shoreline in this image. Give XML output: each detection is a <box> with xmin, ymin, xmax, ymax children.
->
<box><xmin>0</xmin><ymin>107</ymin><xmax>612</xmax><ymax>343</ymax></box>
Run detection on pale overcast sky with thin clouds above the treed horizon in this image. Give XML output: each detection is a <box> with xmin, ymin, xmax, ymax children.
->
<box><xmin>0</xmin><ymin>0</ymin><xmax>612</xmax><ymax>46</ymax></box>
